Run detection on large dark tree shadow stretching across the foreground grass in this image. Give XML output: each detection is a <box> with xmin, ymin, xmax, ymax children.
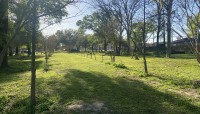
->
<box><xmin>34</xmin><ymin>69</ymin><xmax>200</xmax><ymax>114</ymax></box>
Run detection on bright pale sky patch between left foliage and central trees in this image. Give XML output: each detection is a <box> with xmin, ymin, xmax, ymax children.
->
<box><xmin>40</xmin><ymin>3</ymin><xmax>94</xmax><ymax>36</ymax></box>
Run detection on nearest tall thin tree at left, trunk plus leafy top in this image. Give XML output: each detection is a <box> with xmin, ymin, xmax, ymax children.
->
<box><xmin>26</xmin><ymin>0</ymin><xmax>74</xmax><ymax>113</ymax></box>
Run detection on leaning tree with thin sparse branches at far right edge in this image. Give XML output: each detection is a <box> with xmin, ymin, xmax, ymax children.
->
<box><xmin>173</xmin><ymin>0</ymin><xmax>200</xmax><ymax>64</ymax></box>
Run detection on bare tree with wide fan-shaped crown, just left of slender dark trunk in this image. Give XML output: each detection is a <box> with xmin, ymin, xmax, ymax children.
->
<box><xmin>94</xmin><ymin>0</ymin><xmax>141</xmax><ymax>54</ymax></box>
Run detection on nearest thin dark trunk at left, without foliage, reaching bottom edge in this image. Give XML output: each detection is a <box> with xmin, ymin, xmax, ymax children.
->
<box><xmin>31</xmin><ymin>0</ymin><xmax>37</xmax><ymax>114</ymax></box>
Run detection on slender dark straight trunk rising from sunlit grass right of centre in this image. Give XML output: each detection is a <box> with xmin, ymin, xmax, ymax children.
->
<box><xmin>143</xmin><ymin>0</ymin><xmax>148</xmax><ymax>74</ymax></box>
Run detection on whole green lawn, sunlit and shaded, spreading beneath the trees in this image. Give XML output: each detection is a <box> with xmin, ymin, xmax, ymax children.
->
<box><xmin>0</xmin><ymin>53</ymin><xmax>200</xmax><ymax>114</ymax></box>
